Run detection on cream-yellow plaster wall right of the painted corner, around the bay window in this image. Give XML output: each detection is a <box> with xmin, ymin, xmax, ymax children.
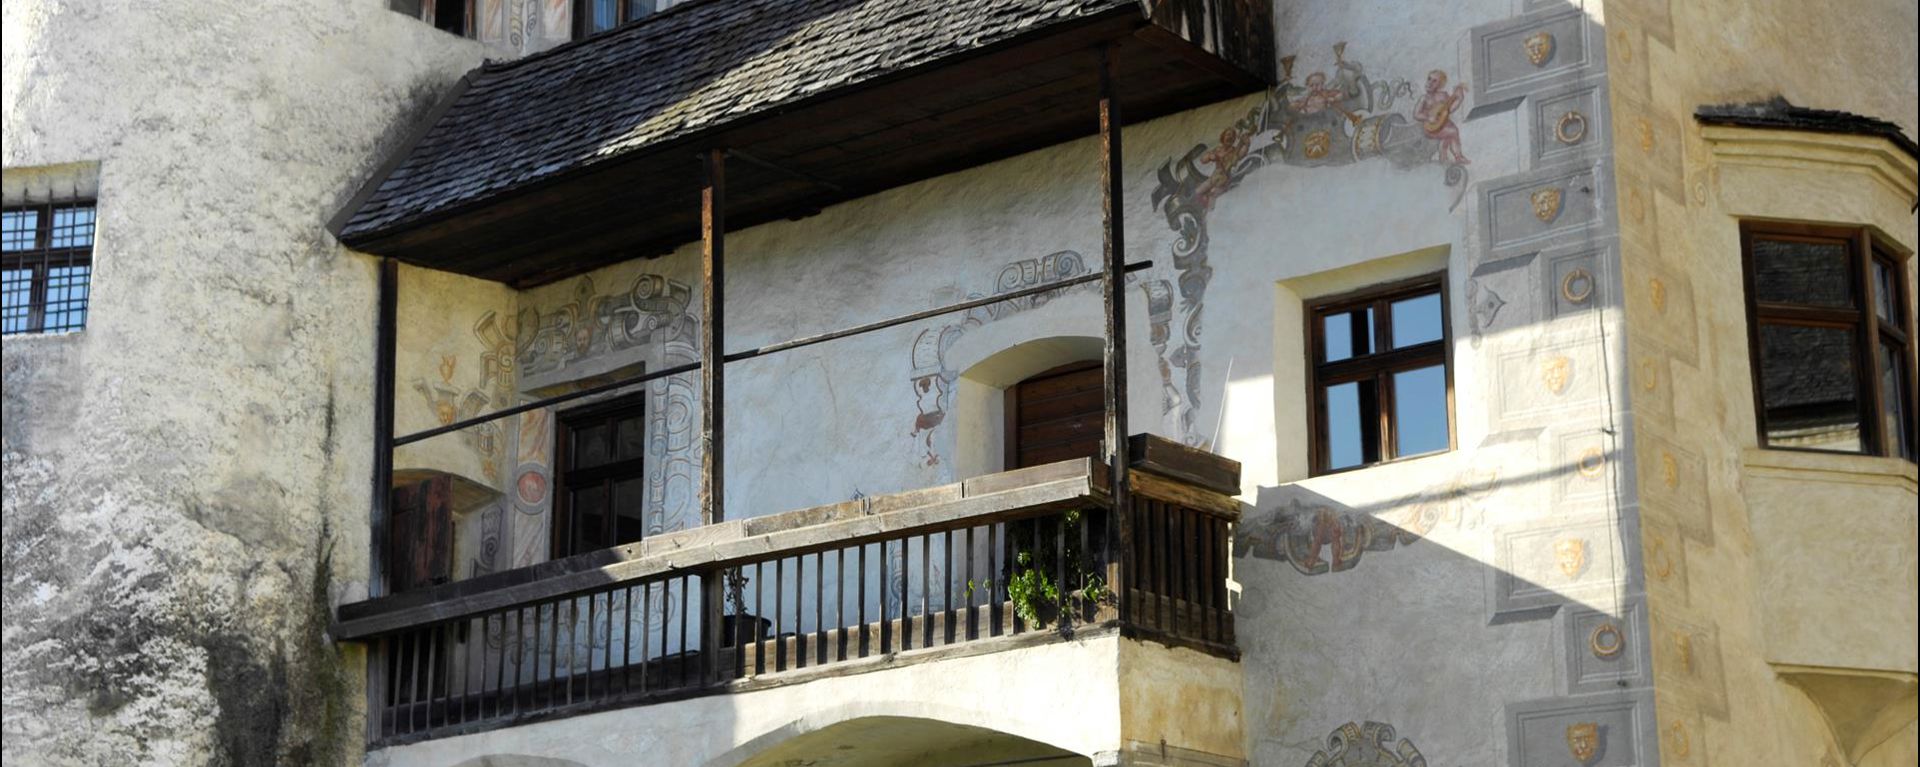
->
<box><xmin>1607</xmin><ymin>0</ymin><xmax>1920</xmax><ymax>765</ymax></box>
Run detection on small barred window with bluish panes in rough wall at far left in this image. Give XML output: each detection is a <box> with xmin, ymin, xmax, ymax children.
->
<box><xmin>0</xmin><ymin>200</ymin><xmax>94</xmax><ymax>334</ymax></box>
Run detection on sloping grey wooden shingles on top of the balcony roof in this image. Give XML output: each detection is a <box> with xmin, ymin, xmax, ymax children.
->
<box><xmin>340</xmin><ymin>0</ymin><xmax>1144</xmax><ymax>244</ymax></box>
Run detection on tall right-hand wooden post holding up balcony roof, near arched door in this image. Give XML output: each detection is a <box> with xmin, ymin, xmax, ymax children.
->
<box><xmin>1100</xmin><ymin>44</ymin><xmax>1133</xmax><ymax>621</ymax></box>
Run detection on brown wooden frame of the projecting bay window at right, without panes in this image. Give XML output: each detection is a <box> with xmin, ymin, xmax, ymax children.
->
<box><xmin>1740</xmin><ymin>221</ymin><xmax>1920</xmax><ymax>461</ymax></box>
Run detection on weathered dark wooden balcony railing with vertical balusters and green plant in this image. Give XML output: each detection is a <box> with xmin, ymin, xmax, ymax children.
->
<box><xmin>334</xmin><ymin>436</ymin><xmax>1238</xmax><ymax>744</ymax></box>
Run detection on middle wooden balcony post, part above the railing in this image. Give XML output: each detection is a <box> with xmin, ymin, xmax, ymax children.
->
<box><xmin>706</xmin><ymin>148</ymin><xmax>726</xmax><ymax>530</ymax></box>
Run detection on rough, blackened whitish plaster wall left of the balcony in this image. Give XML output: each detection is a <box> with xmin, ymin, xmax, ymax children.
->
<box><xmin>0</xmin><ymin>0</ymin><xmax>480</xmax><ymax>765</ymax></box>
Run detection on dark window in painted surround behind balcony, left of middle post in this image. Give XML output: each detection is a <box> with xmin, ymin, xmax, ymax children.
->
<box><xmin>553</xmin><ymin>396</ymin><xmax>647</xmax><ymax>557</ymax></box>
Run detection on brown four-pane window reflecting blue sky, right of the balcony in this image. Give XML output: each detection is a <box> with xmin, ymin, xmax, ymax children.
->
<box><xmin>1308</xmin><ymin>273</ymin><xmax>1453</xmax><ymax>475</ymax></box>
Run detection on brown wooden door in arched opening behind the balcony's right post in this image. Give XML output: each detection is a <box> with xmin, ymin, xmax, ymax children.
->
<box><xmin>1006</xmin><ymin>361</ymin><xmax>1106</xmax><ymax>469</ymax></box>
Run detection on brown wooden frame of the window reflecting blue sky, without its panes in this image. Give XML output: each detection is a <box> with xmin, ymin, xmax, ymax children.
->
<box><xmin>1306</xmin><ymin>269</ymin><xmax>1459</xmax><ymax>477</ymax></box>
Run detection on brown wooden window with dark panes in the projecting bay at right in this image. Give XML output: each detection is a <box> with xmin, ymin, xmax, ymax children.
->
<box><xmin>1741</xmin><ymin>223</ymin><xmax>1914</xmax><ymax>459</ymax></box>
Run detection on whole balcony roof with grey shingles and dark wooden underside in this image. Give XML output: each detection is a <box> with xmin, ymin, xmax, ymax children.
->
<box><xmin>336</xmin><ymin>0</ymin><xmax>1275</xmax><ymax>288</ymax></box>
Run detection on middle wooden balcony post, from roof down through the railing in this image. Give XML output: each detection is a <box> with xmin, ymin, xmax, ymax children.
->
<box><xmin>698</xmin><ymin>148</ymin><xmax>726</xmax><ymax>684</ymax></box>
